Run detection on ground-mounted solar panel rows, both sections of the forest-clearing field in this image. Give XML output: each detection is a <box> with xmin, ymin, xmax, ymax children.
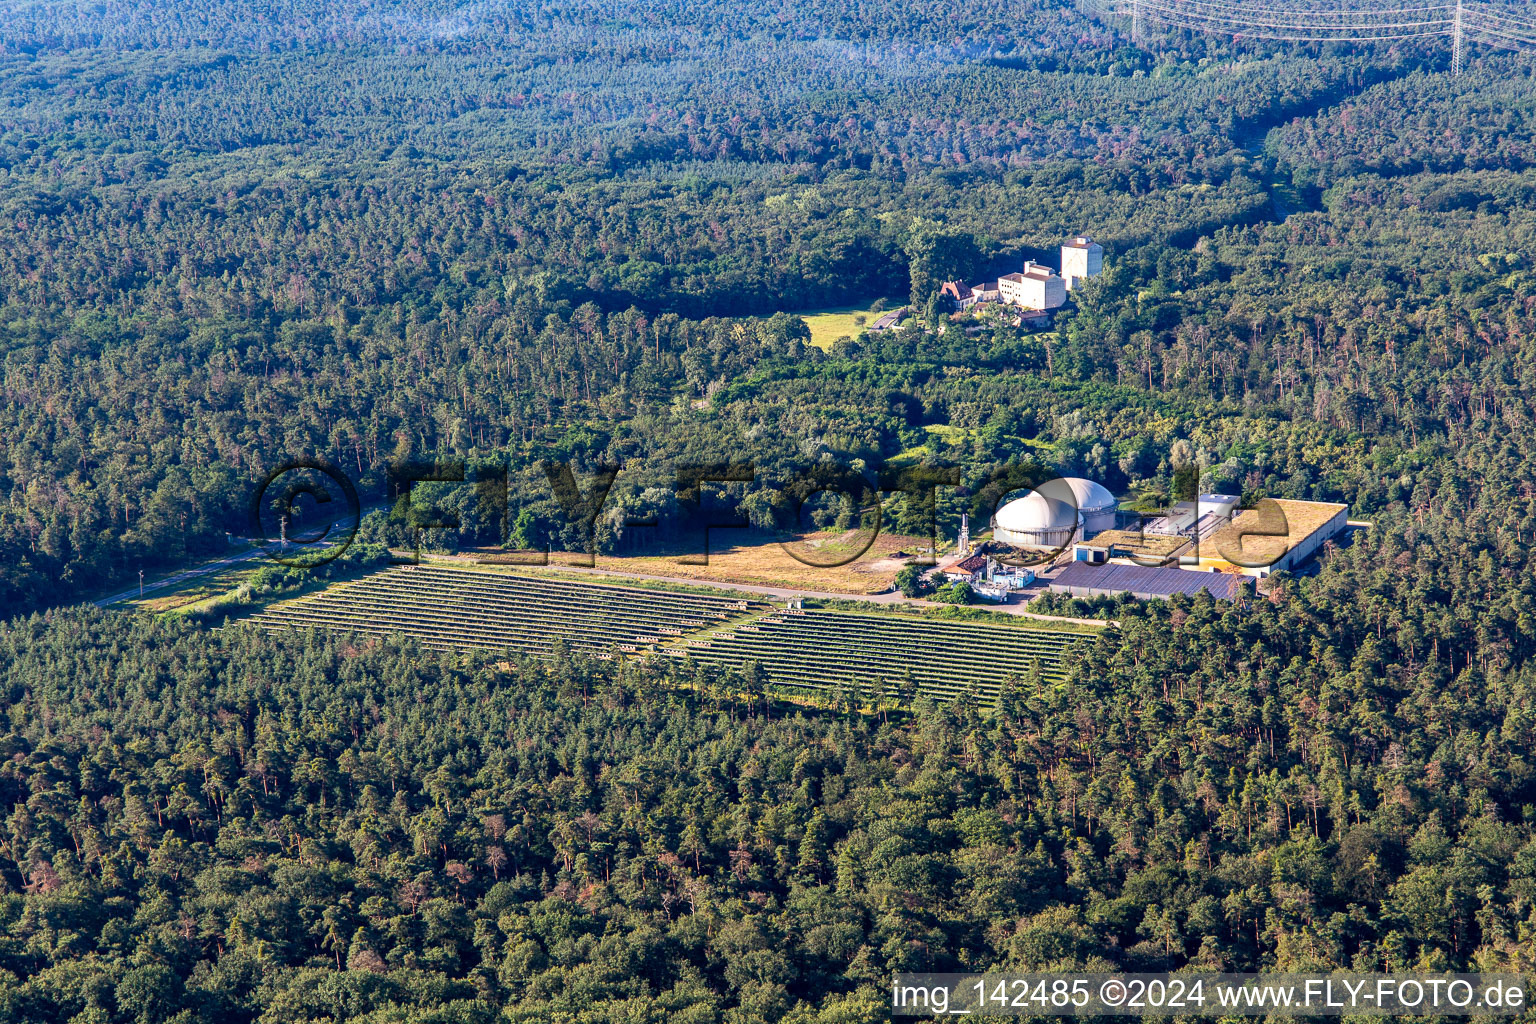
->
<box><xmin>252</xmin><ymin>565</ymin><xmax>1095</xmax><ymax>702</ymax></box>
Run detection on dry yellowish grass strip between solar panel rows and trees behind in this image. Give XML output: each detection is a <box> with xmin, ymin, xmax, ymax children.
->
<box><xmin>465</xmin><ymin>530</ymin><xmax>928</xmax><ymax>594</ymax></box>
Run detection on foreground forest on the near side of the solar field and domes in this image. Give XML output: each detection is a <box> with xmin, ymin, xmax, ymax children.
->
<box><xmin>9</xmin><ymin>540</ymin><xmax>1536</xmax><ymax>1022</ymax></box>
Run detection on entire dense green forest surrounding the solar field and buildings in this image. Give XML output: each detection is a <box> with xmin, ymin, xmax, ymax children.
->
<box><xmin>0</xmin><ymin>0</ymin><xmax>1536</xmax><ymax>1024</ymax></box>
